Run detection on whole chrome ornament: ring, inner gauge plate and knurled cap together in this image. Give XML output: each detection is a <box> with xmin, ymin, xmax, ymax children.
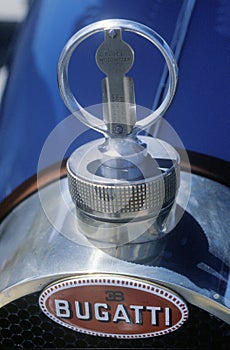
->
<box><xmin>58</xmin><ymin>20</ymin><xmax>179</xmax><ymax>239</ymax></box>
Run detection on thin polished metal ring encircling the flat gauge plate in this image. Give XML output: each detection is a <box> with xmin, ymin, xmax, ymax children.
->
<box><xmin>58</xmin><ymin>19</ymin><xmax>177</xmax><ymax>134</ymax></box>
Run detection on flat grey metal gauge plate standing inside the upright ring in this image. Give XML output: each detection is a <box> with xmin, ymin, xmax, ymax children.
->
<box><xmin>96</xmin><ymin>30</ymin><xmax>136</xmax><ymax>136</ymax></box>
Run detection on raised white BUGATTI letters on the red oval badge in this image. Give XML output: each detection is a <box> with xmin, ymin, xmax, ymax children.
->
<box><xmin>55</xmin><ymin>299</ymin><xmax>171</xmax><ymax>327</ymax></box>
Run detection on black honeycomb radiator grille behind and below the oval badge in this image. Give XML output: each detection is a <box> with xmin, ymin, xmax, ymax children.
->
<box><xmin>0</xmin><ymin>293</ymin><xmax>230</xmax><ymax>350</ymax></box>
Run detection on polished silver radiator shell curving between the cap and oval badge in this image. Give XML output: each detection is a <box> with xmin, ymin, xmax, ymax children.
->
<box><xmin>0</xmin><ymin>173</ymin><xmax>230</xmax><ymax>323</ymax></box>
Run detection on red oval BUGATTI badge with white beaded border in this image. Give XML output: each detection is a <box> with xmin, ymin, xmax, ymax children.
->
<box><xmin>39</xmin><ymin>275</ymin><xmax>188</xmax><ymax>338</ymax></box>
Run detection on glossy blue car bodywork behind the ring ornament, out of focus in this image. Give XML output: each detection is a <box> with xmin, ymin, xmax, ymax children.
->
<box><xmin>0</xmin><ymin>0</ymin><xmax>230</xmax><ymax>198</ymax></box>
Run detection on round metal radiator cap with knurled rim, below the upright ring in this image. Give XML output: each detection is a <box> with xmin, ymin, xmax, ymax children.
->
<box><xmin>67</xmin><ymin>136</ymin><xmax>180</xmax><ymax>221</ymax></box>
